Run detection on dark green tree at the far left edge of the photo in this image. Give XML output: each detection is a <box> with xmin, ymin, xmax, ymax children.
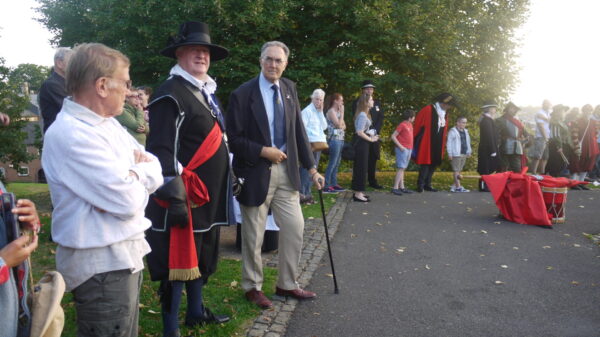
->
<box><xmin>0</xmin><ymin>58</ymin><xmax>31</xmax><ymax>176</ymax></box>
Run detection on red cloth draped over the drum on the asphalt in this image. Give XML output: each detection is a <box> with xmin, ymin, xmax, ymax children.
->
<box><xmin>481</xmin><ymin>167</ymin><xmax>583</xmax><ymax>226</ymax></box>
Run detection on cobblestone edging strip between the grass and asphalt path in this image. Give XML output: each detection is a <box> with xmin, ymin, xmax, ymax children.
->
<box><xmin>246</xmin><ymin>191</ymin><xmax>352</xmax><ymax>337</ymax></box>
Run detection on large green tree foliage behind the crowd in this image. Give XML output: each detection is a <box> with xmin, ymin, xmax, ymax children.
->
<box><xmin>37</xmin><ymin>0</ymin><xmax>529</xmax><ymax>168</ymax></box>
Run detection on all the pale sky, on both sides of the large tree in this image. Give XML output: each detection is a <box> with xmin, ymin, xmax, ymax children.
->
<box><xmin>0</xmin><ymin>0</ymin><xmax>600</xmax><ymax>106</ymax></box>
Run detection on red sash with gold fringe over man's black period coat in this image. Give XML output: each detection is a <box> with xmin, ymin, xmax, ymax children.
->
<box><xmin>169</xmin><ymin>122</ymin><xmax>223</xmax><ymax>281</ymax></box>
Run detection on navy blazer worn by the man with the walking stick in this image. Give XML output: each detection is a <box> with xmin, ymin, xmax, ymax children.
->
<box><xmin>226</xmin><ymin>77</ymin><xmax>315</xmax><ymax>206</ymax></box>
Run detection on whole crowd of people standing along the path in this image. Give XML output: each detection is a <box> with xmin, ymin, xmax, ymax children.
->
<box><xmin>0</xmin><ymin>17</ymin><xmax>600</xmax><ymax>336</ymax></box>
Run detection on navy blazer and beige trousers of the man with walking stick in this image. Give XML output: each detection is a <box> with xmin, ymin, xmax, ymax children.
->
<box><xmin>227</xmin><ymin>76</ymin><xmax>314</xmax><ymax>292</ymax></box>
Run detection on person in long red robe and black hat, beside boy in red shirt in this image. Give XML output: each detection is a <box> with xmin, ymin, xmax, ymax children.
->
<box><xmin>412</xmin><ymin>93</ymin><xmax>456</xmax><ymax>192</ymax></box>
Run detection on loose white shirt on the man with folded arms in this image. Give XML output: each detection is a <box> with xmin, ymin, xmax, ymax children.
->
<box><xmin>42</xmin><ymin>97</ymin><xmax>163</xmax><ymax>290</ymax></box>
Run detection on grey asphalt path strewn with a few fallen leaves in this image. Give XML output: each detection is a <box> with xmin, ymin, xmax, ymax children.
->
<box><xmin>286</xmin><ymin>190</ymin><xmax>600</xmax><ymax>337</ymax></box>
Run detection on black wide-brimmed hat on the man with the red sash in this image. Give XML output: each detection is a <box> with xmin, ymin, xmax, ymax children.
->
<box><xmin>160</xmin><ymin>21</ymin><xmax>229</xmax><ymax>61</ymax></box>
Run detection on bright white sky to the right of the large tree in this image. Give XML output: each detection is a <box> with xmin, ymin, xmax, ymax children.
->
<box><xmin>512</xmin><ymin>0</ymin><xmax>600</xmax><ymax>106</ymax></box>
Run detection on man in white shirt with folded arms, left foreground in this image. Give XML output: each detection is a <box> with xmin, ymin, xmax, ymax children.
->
<box><xmin>42</xmin><ymin>43</ymin><xmax>163</xmax><ymax>336</ymax></box>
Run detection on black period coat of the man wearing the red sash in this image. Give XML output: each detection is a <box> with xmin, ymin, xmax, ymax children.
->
<box><xmin>146</xmin><ymin>76</ymin><xmax>235</xmax><ymax>281</ymax></box>
